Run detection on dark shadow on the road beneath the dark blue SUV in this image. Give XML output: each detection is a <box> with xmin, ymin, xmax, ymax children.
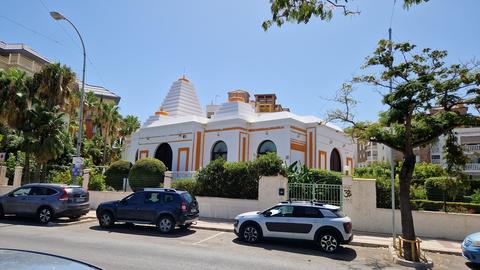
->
<box><xmin>90</xmin><ymin>224</ymin><xmax>195</xmax><ymax>238</ymax></box>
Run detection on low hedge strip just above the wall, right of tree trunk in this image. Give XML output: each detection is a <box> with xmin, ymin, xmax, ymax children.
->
<box><xmin>411</xmin><ymin>200</ymin><xmax>480</xmax><ymax>214</ymax></box>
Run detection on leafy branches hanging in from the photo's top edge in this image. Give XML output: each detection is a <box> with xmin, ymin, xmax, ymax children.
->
<box><xmin>262</xmin><ymin>0</ymin><xmax>428</xmax><ymax>30</ymax></box>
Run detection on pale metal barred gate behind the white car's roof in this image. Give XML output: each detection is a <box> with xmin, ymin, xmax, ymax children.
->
<box><xmin>288</xmin><ymin>183</ymin><xmax>342</xmax><ymax>207</ymax></box>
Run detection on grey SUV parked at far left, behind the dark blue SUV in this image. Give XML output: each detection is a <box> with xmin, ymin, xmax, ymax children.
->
<box><xmin>0</xmin><ymin>184</ymin><xmax>90</xmax><ymax>223</ymax></box>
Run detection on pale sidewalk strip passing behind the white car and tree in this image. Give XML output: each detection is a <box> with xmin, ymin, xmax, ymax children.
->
<box><xmin>192</xmin><ymin>218</ymin><xmax>462</xmax><ymax>255</ymax></box>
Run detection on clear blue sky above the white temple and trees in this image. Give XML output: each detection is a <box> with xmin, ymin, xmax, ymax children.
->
<box><xmin>0</xmin><ymin>0</ymin><xmax>480</xmax><ymax>122</ymax></box>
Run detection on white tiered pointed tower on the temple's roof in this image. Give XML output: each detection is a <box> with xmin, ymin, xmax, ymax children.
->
<box><xmin>161</xmin><ymin>75</ymin><xmax>204</xmax><ymax>117</ymax></box>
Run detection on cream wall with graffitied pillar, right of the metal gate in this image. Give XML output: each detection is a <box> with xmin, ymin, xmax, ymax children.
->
<box><xmin>343</xmin><ymin>176</ymin><xmax>480</xmax><ymax>240</ymax></box>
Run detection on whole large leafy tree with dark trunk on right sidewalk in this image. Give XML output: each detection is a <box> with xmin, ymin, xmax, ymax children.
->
<box><xmin>329</xmin><ymin>40</ymin><xmax>480</xmax><ymax>259</ymax></box>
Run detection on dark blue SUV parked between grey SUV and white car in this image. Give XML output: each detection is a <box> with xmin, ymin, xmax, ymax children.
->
<box><xmin>97</xmin><ymin>188</ymin><xmax>199</xmax><ymax>233</ymax></box>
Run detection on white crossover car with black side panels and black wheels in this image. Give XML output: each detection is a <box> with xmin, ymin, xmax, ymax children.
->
<box><xmin>234</xmin><ymin>201</ymin><xmax>353</xmax><ymax>253</ymax></box>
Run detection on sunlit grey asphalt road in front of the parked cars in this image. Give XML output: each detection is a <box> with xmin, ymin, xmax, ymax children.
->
<box><xmin>0</xmin><ymin>218</ymin><xmax>469</xmax><ymax>270</ymax></box>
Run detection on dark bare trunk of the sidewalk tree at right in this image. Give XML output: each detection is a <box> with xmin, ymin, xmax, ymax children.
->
<box><xmin>399</xmin><ymin>151</ymin><xmax>418</xmax><ymax>261</ymax></box>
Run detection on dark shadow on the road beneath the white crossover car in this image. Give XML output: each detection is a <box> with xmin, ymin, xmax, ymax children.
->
<box><xmin>232</xmin><ymin>238</ymin><xmax>357</xmax><ymax>261</ymax></box>
